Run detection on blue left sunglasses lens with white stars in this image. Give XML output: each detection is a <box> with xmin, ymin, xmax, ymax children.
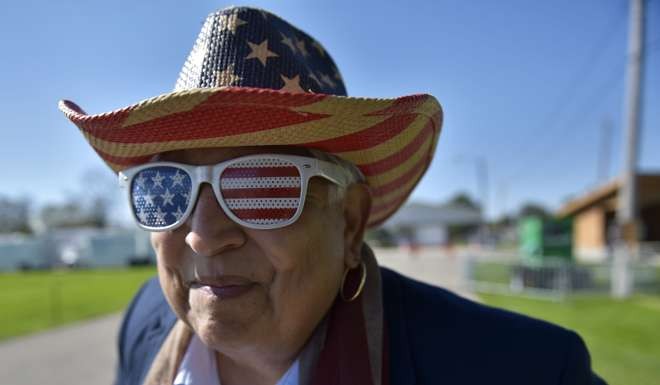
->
<box><xmin>130</xmin><ymin>166</ymin><xmax>192</xmax><ymax>228</ymax></box>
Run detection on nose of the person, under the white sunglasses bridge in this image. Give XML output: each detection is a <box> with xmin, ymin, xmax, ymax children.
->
<box><xmin>185</xmin><ymin>184</ymin><xmax>246</xmax><ymax>257</ymax></box>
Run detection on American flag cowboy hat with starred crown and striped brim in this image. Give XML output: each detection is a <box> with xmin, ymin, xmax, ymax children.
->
<box><xmin>59</xmin><ymin>7</ymin><xmax>442</xmax><ymax>227</ymax></box>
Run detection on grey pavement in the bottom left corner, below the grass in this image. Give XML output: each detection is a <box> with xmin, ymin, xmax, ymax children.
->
<box><xmin>0</xmin><ymin>314</ymin><xmax>121</xmax><ymax>385</ymax></box>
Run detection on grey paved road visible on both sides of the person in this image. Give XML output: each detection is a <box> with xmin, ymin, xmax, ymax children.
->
<box><xmin>0</xmin><ymin>249</ymin><xmax>471</xmax><ymax>385</ymax></box>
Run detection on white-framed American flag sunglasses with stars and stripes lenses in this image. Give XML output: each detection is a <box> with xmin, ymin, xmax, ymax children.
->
<box><xmin>119</xmin><ymin>154</ymin><xmax>348</xmax><ymax>231</ymax></box>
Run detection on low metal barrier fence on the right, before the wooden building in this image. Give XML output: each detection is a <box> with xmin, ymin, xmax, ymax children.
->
<box><xmin>464</xmin><ymin>257</ymin><xmax>660</xmax><ymax>300</ymax></box>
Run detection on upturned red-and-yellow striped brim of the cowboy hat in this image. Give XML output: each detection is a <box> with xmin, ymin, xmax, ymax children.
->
<box><xmin>59</xmin><ymin>87</ymin><xmax>442</xmax><ymax>227</ymax></box>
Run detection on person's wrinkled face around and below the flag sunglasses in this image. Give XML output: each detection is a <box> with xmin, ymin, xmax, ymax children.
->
<box><xmin>151</xmin><ymin>148</ymin><xmax>368</xmax><ymax>354</ymax></box>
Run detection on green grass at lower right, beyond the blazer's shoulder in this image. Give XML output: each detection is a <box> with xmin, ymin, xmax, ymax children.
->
<box><xmin>479</xmin><ymin>294</ymin><xmax>660</xmax><ymax>385</ymax></box>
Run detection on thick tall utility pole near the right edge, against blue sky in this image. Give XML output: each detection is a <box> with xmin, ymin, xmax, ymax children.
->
<box><xmin>612</xmin><ymin>0</ymin><xmax>644</xmax><ymax>298</ymax></box>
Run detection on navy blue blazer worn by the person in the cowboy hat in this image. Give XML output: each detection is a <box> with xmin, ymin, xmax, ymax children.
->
<box><xmin>115</xmin><ymin>268</ymin><xmax>605</xmax><ymax>385</ymax></box>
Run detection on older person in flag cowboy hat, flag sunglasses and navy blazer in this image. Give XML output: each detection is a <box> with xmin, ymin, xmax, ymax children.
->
<box><xmin>60</xmin><ymin>7</ymin><xmax>602</xmax><ymax>385</ymax></box>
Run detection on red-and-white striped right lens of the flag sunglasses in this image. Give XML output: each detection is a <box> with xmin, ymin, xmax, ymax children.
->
<box><xmin>220</xmin><ymin>157</ymin><xmax>301</xmax><ymax>225</ymax></box>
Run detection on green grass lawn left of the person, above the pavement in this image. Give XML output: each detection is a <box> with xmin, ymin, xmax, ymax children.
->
<box><xmin>0</xmin><ymin>267</ymin><xmax>156</xmax><ymax>340</ymax></box>
